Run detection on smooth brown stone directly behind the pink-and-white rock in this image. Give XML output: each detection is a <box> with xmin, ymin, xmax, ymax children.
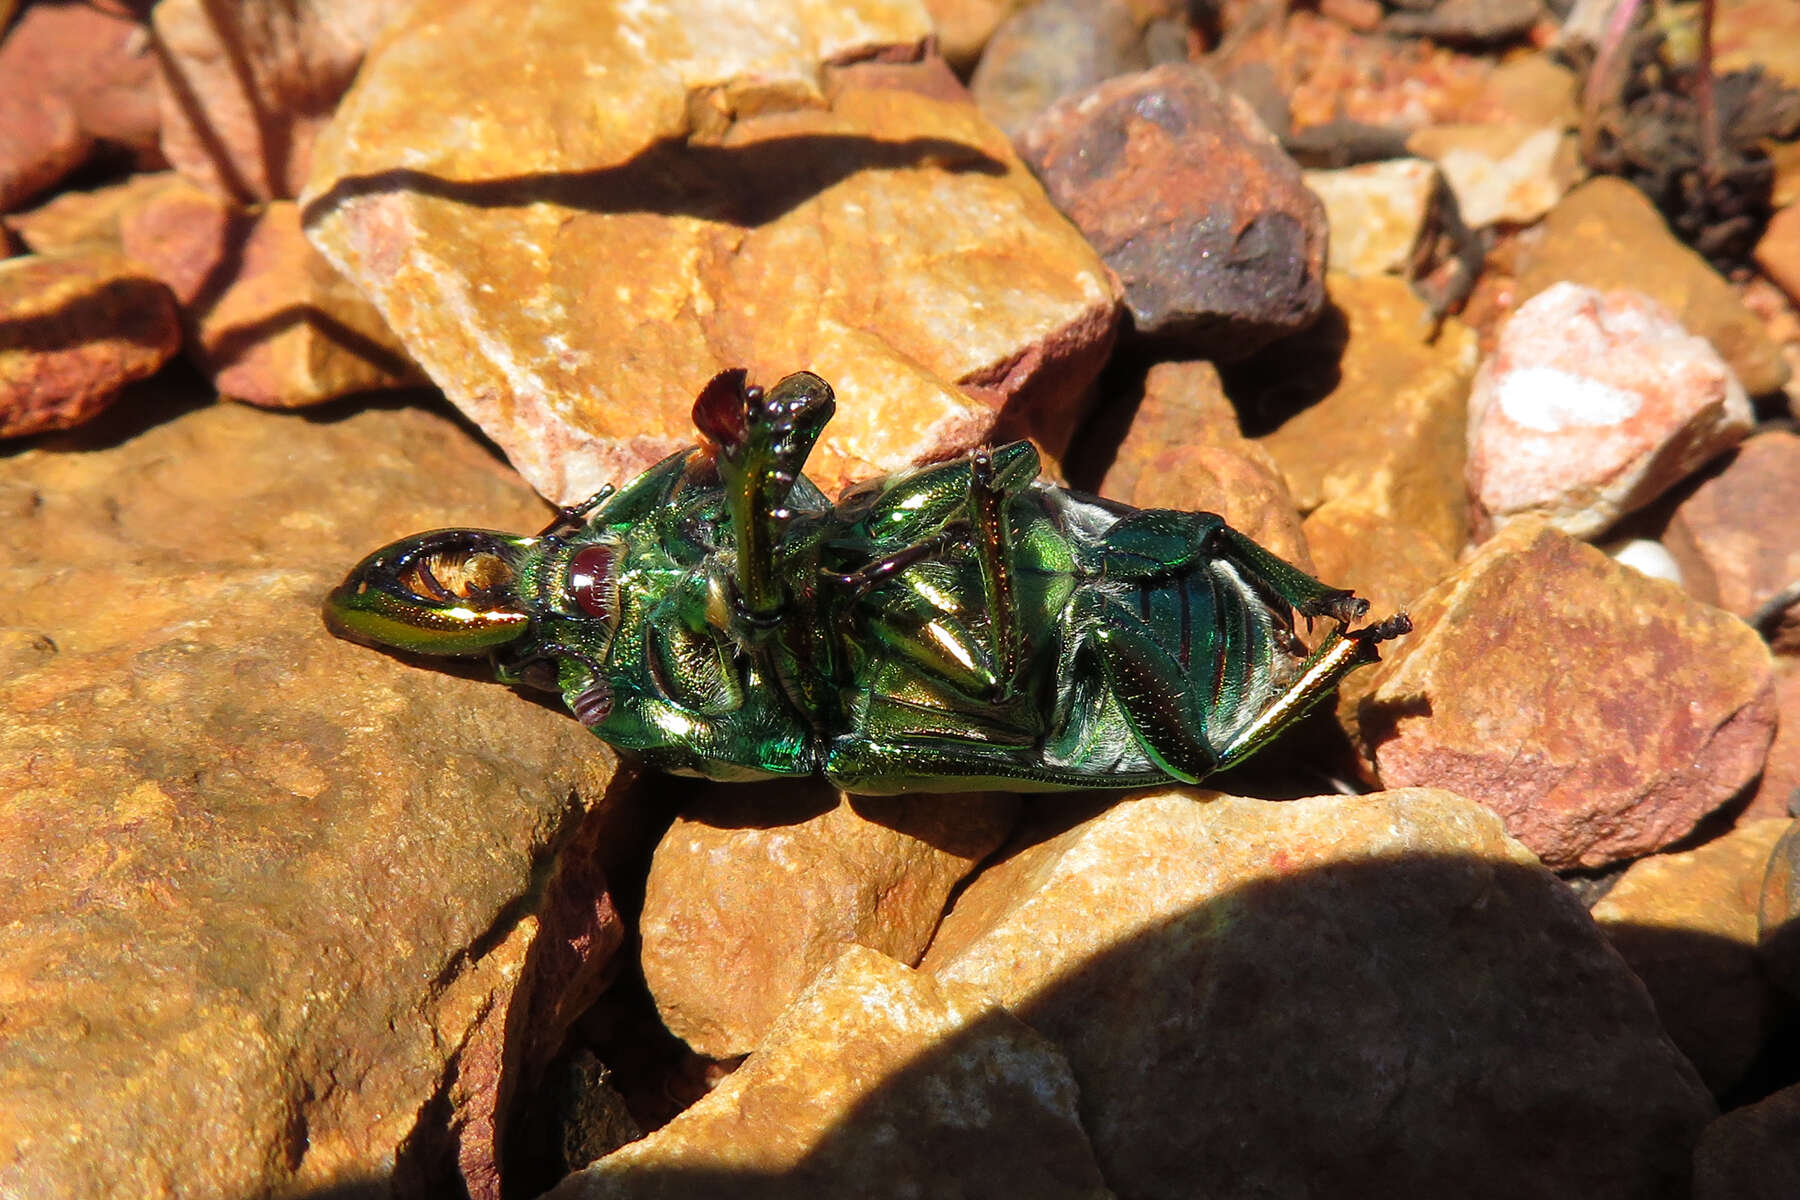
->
<box><xmin>1517</xmin><ymin>176</ymin><xmax>1787</xmax><ymax>396</ymax></box>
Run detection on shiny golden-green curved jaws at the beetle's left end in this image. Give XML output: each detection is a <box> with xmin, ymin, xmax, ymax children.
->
<box><xmin>326</xmin><ymin>529</ymin><xmax>535</xmax><ymax>655</ymax></box>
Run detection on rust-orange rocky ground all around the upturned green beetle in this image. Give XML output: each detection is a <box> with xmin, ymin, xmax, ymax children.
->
<box><xmin>10</xmin><ymin>0</ymin><xmax>1800</xmax><ymax>1200</ymax></box>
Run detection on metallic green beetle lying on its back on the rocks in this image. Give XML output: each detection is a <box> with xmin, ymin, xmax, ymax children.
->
<box><xmin>326</xmin><ymin>371</ymin><xmax>1411</xmax><ymax>793</ymax></box>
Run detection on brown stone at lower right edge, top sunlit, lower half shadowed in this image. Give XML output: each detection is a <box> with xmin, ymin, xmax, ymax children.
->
<box><xmin>1591</xmin><ymin>820</ymin><xmax>1795</xmax><ymax>1096</ymax></box>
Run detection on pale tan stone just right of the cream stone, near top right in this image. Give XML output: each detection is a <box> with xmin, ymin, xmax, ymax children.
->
<box><xmin>1406</xmin><ymin>124</ymin><xmax>1586</xmax><ymax>228</ymax></box>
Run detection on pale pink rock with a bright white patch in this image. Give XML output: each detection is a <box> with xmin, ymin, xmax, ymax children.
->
<box><xmin>1467</xmin><ymin>282</ymin><xmax>1751</xmax><ymax>538</ymax></box>
